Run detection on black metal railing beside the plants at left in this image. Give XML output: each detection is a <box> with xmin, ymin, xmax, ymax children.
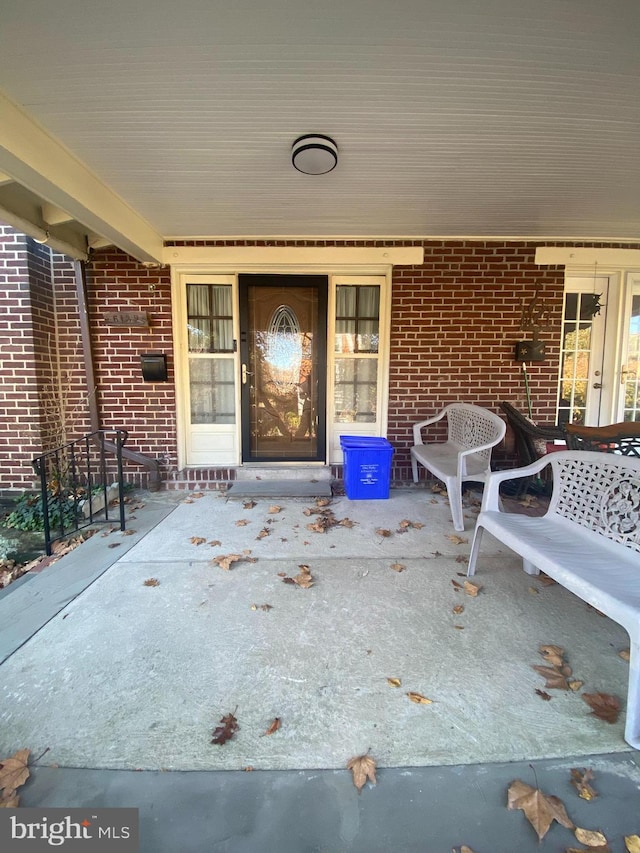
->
<box><xmin>33</xmin><ymin>430</ymin><xmax>128</xmax><ymax>554</ymax></box>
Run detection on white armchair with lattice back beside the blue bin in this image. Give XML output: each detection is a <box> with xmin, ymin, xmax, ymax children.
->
<box><xmin>411</xmin><ymin>403</ymin><xmax>506</xmax><ymax>530</ymax></box>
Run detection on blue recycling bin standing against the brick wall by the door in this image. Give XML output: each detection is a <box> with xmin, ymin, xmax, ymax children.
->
<box><xmin>340</xmin><ymin>435</ymin><xmax>393</xmax><ymax>501</ymax></box>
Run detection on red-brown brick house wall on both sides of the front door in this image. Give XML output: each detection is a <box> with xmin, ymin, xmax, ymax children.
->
<box><xmin>0</xmin><ymin>229</ymin><xmax>636</xmax><ymax>488</ymax></box>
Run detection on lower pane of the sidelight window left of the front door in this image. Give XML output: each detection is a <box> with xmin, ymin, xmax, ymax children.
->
<box><xmin>189</xmin><ymin>358</ymin><xmax>236</xmax><ymax>424</ymax></box>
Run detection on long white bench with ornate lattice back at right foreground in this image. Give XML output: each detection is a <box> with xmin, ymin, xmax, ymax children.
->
<box><xmin>468</xmin><ymin>450</ymin><xmax>640</xmax><ymax>749</ymax></box>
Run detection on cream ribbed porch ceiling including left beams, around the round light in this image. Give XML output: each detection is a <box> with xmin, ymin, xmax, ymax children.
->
<box><xmin>0</xmin><ymin>0</ymin><xmax>640</xmax><ymax>263</ymax></box>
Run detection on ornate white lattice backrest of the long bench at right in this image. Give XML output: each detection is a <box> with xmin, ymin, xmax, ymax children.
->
<box><xmin>549</xmin><ymin>450</ymin><xmax>640</xmax><ymax>552</ymax></box>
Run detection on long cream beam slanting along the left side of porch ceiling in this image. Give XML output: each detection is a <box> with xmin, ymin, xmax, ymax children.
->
<box><xmin>0</xmin><ymin>93</ymin><xmax>163</xmax><ymax>263</ymax></box>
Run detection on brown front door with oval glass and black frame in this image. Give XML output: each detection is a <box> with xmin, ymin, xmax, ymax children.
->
<box><xmin>239</xmin><ymin>274</ymin><xmax>328</xmax><ymax>462</ymax></box>
